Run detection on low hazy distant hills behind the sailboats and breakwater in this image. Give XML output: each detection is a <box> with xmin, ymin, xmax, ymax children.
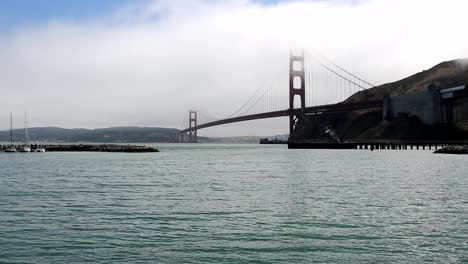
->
<box><xmin>0</xmin><ymin>127</ymin><xmax>179</xmax><ymax>143</ymax></box>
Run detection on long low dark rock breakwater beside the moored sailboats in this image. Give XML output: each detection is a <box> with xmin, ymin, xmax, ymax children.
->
<box><xmin>43</xmin><ymin>144</ymin><xmax>159</xmax><ymax>153</ymax></box>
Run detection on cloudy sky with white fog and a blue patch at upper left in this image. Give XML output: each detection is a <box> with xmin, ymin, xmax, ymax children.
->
<box><xmin>0</xmin><ymin>0</ymin><xmax>468</xmax><ymax>136</ymax></box>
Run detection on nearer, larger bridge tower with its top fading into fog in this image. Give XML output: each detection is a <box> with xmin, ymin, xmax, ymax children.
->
<box><xmin>289</xmin><ymin>51</ymin><xmax>305</xmax><ymax>139</ymax></box>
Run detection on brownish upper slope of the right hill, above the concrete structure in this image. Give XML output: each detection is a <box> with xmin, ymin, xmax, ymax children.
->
<box><xmin>345</xmin><ymin>59</ymin><xmax>468</xmax><ymax>103</ymax></box>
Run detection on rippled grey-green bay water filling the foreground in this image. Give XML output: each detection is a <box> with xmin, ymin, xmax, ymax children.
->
<box><xmin>0</xmin><ymin>145</ymin><xmax>468</xmax><ymax>263</ymax></box>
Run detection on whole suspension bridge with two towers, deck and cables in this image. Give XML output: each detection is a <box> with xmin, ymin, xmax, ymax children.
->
<box><xmin>179</xmin><ymin>50</ymin><xmax>383</xmax><ymax>143</ymax></box>
